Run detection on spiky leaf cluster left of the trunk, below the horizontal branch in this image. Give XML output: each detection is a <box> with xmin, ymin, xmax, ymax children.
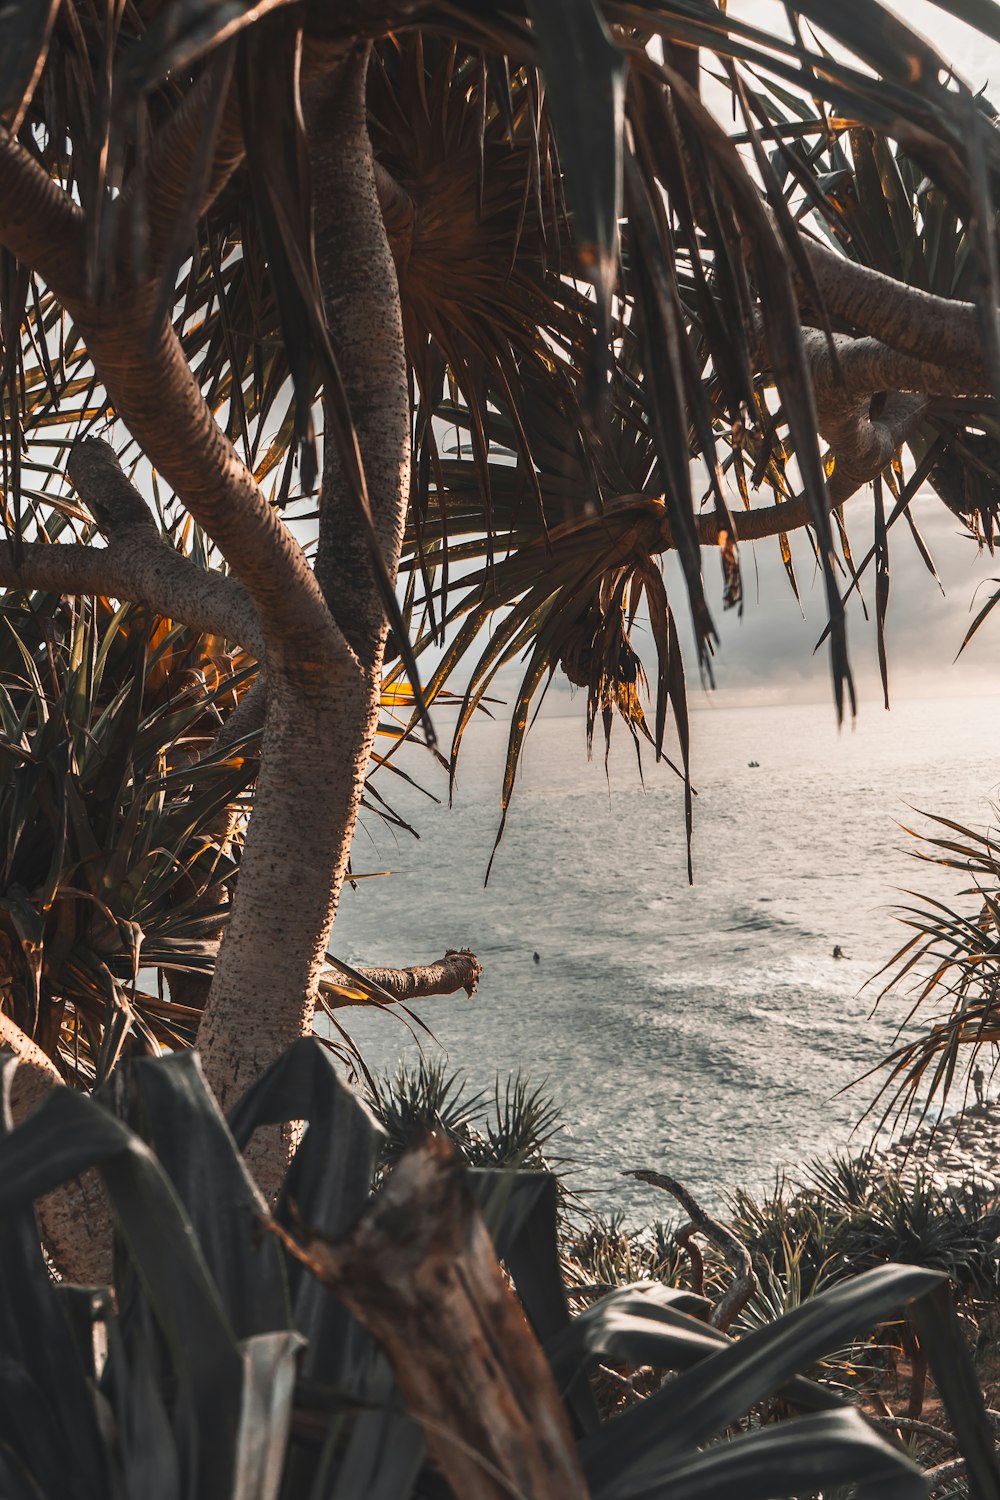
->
<box><xmin>0</xmin><ymin>593</ymin><xmax>255</xmax><ymax>1086</ymax></box>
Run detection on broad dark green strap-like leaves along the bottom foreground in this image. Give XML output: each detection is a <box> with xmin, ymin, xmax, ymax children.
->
<box><xmin>0</xmin><ymin>1041</ymin><xmax>1000</xmax><ymax>1500</ymax></box>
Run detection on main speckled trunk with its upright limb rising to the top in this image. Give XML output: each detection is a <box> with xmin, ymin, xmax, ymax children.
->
<box><xmin>198</xmin><ymin>41</ymin><xmax>409</xmax><ymax>1196</ymax></box>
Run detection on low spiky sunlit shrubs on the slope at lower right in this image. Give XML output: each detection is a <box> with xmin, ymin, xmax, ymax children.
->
<box><xmin>564</xmin><ymin>1154</ymin><xmax>1000</xmax><ymax>1449</ymax></box>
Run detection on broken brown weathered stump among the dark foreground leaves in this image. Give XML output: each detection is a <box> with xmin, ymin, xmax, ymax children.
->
<box><xmin>275</xmin><ymin>1136</ymin><xmax>588</xmax><ymax>1500</ymax></box>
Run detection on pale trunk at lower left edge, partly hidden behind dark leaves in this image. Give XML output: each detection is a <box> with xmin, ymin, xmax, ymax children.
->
<box><xmin>0</xmin><ymin>1013</ymin><xmax>111</xmax><ymax>1286</ymax></box>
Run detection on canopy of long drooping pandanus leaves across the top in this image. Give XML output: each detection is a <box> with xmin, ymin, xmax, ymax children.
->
<box><xmin>0</xmin><ymin>0</ymin><xmax>1000</xmax><ymax>858</ymax></box>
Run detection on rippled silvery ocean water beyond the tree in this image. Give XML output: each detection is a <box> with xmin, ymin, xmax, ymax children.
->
<box><xmin>333</xmin><ymin>696</ymin><xmax>1000</xmax><ymax>1221</ymax></box>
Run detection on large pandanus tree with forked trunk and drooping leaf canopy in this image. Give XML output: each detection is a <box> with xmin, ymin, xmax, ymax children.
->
<box><xmin>0</xmin><ymin>0</ymin><xmax>1000</xmax><ymax>1278</ymax></box>
